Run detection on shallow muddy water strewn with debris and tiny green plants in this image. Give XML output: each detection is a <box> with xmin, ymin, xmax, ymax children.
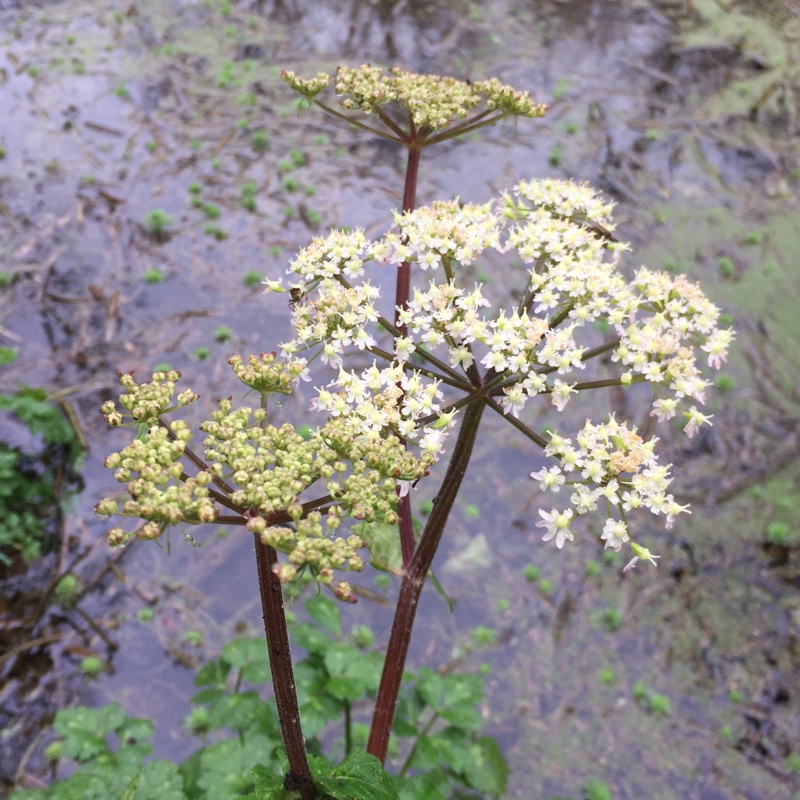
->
<box><xmin>0</xmin><ymin>0</ymin><xmax>800</xmax><ymax>800</ymax></box>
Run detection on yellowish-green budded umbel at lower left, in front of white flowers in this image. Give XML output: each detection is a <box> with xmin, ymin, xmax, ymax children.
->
<box><xmin>95</xmin><ymin>362</ymin><xmax>433</xmax><ymax>600</ymax></box>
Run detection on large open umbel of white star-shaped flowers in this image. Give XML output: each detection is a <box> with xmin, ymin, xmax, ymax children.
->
<box><xmin>269</xmin><ymin>177</ymin><xmax>733</xmax><ymax>568</ymax></box>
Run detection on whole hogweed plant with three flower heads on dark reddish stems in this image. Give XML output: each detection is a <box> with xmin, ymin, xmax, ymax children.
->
<box><xmin>92</xmin><ymin>66</ymin><xmax>733</xmax><ymax>800</ymax></box>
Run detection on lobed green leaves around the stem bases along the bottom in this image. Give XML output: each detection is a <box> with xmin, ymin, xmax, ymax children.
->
<box><xmin>11</xmin><ymin>595</ymin><xmax>508</xmax><ymax>800</ymax></box>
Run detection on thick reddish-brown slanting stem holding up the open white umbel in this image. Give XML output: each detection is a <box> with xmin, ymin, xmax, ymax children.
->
<box><xmin>367</xmin><ymin>400</ymin><xmax>484</xmax><ymax>763</ymax></box>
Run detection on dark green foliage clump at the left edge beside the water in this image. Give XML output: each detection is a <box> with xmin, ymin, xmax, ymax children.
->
<box><xmin>0</xmin><ymin>388</ymin><xmax>81</xmax><ymax>564</ymax></box>
